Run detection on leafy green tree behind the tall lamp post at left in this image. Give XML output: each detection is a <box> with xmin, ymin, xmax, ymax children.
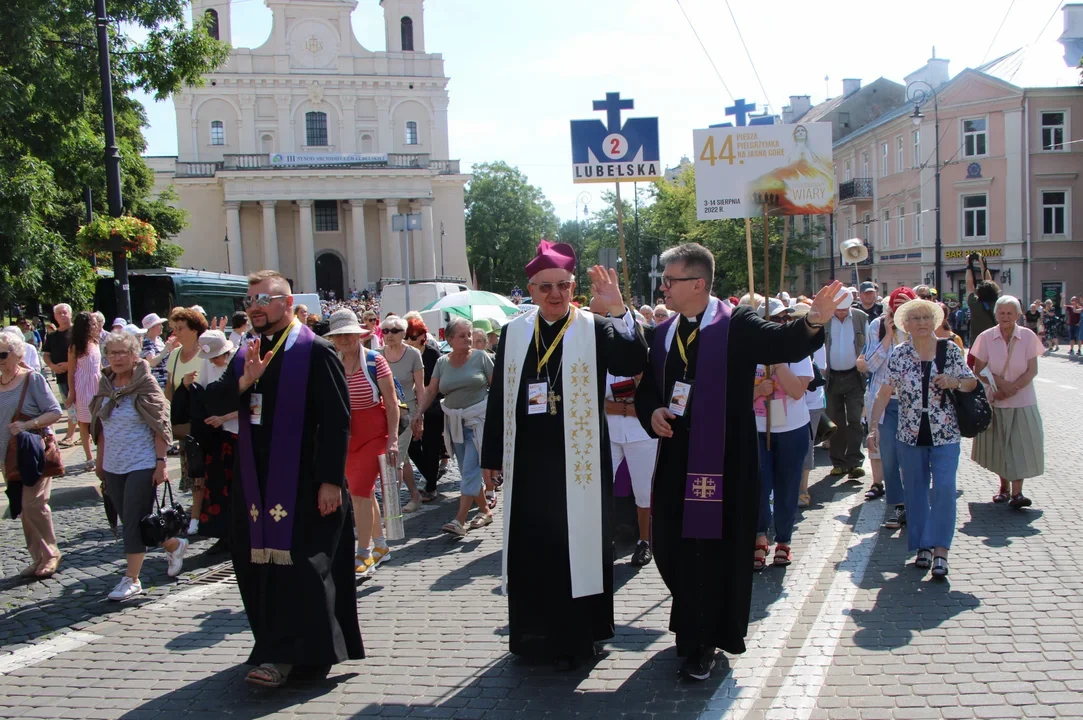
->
<box><xmin>0</xmin><ymin>0</ymin><xmax>229</xmax><ymax>306</ymax></box>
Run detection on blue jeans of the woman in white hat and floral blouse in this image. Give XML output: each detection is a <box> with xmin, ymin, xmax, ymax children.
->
<box><xmin>898</xmin><ymin>443</ymin><xmax>958</xmax><ymax>552</ymax></box>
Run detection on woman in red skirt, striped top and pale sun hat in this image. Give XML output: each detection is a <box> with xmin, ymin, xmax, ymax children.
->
<box><xmin>324</xmin><ymin>307</ymin><xmax>399</xmax><ymax>576</ymax></box>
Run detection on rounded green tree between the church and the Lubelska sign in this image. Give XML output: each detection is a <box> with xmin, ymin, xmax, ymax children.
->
<box><xmin>466</xmin><ymin>162</ymin><xmax>560</xmax><ymax>294</ymax></box>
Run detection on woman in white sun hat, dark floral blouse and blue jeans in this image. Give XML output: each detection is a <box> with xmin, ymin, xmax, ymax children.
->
<box><xmin>869</xmin><ymin>300</ymin><xmax>978</xmax><ymax>577</ymax></box>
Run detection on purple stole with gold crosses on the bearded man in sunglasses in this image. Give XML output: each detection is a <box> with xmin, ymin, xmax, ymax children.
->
<box><xmin>233</xmin><ymin>325</ymin><xmax>315</xmax><ymax>565</ymax></box>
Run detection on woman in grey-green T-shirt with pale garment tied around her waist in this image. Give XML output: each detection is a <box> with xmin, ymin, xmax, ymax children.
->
<box><xmin>413</xmin><ymin>317</ymin><xmax>493</xmax><ymax>537</ymax></box>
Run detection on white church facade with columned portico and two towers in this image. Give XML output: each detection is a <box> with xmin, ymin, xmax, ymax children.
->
<box><xmin>146</xmin><ymin>0</ymin><xmax>470</xmax><ymax>297</ymax></box>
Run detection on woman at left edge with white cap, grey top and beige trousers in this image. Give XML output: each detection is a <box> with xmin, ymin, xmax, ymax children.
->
<box><xmin>0</xmin><ymin>332</ymin><xmax>61</xmax><ymax>578</ymax></box>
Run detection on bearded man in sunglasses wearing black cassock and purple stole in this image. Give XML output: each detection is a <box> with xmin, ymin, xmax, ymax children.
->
<box><xmin>206</xmin><ymin>271</ymin><xmax>364</xmax><ymax>688</ymax></box>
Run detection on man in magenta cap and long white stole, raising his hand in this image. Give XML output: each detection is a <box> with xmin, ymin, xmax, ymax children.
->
<box><xmin>481</xmin><ymin>240</ymin><xmax>647</xmax><ymax>669</ymax></box>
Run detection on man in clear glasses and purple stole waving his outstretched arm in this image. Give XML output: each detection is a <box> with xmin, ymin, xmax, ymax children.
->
<box><xmin>636</xmin><ymin>243</ymin><xmax>841</xmax><ymax>680</ymax></box>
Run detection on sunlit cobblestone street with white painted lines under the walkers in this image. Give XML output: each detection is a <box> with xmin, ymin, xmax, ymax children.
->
<box><xmin>0</xmin><ymin>352</ymin><xmax>1083</xmax><ymax>720</ymax></box>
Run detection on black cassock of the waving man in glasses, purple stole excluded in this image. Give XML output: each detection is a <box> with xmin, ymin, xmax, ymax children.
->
<box><xmin>636</xmin><ymin>307</ymin><xmax>823</xmax><ymax>657</ymax></box>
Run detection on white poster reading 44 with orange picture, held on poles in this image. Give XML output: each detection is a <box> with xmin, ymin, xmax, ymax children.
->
<box><xmin>693</xmin><ymin>122</ymin><xmax>835</xmax><ymax>220</ymax></box>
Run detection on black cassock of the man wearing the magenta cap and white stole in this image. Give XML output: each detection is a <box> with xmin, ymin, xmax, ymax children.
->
<box><xmin>481</xmin><ymin>316</ymin><xmax>647</xmax><ymax>659</ymax></box>
